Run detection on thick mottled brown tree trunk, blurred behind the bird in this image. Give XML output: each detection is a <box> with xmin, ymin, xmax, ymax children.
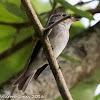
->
<box><xmin>0</xmin><ymin>22</ymin><xmax>100</xmax><ymax>100</ymax></box>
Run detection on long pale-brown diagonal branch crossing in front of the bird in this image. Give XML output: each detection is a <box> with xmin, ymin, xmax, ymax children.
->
<box><xmin>21</xmin><ymin>0</ymin><xmax>73</xmax><ymax>100</ymax></box>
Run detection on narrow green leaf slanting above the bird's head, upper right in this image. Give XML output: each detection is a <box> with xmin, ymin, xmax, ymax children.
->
<box><xmin>55</xmin><ymin>0</ymin><xmax>93</xmax><ymax>20</ymax></box>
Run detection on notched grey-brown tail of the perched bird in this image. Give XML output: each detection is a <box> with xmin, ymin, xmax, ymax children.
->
<box><xmin>13</xmin><ymin>73</ymin><xmax>34</xmax><ymax>92</ymax></box>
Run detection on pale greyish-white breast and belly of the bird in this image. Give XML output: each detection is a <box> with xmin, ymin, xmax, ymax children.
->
<box><xmin>49</xmin><ymin>25</ymin><xmax>69</xmax><ymax>58</ymax></box>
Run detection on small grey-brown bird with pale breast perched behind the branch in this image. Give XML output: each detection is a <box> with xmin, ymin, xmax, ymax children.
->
<box><xmin>13</xmin><ymin>12</ymin><xmax>78</xmax><ymax>92</ymax></box>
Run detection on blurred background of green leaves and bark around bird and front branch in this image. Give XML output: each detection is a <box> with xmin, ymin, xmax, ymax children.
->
<box><xmin>0</xmin><ymin>0</ymin><xmax>100</xmax><ymax>100</ymax></box>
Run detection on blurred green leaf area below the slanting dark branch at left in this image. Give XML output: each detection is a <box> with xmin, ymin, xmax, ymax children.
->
<box><xmin>0</xmin><ymin>43</ymin><xmax>33</xmax><ymax>84</ymax></box>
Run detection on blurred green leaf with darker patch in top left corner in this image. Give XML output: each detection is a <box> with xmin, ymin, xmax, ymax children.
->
<box><xmin>0</xmin><ymin>0</ymin><xmax>28</xmax><ymax>23</ymax></box>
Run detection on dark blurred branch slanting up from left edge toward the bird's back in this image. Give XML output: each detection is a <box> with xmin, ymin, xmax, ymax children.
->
<box><xmin>0</xmin><ymin>37</ymin><xmax>32</xmax><ymax>61</ymax></box>
